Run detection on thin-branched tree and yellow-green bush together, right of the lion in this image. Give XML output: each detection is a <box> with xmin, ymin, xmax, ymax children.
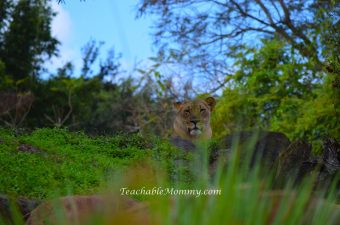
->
<box><xmin>139</xmin><ymin>0</ymin><xmax>340</xmax><ymax>144</ymax></box>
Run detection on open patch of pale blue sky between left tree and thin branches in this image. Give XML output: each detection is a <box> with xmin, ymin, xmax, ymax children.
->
<box><xmin>46</xmin><ymin>0</ymin><xmax>153</xmax><ymax>75</ymax></box>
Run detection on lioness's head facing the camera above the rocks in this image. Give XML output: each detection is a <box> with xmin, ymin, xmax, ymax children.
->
<box><xmin>174</xmin><ymin>97</ymin><xmax>216</xmax><ymax>140</ymax></box>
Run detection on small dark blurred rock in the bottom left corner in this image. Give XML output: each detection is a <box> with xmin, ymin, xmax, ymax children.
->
<box><xmin>0</xmin><ymin>195</ymin><xmax>41</xmax><ymax>224</ymax></box>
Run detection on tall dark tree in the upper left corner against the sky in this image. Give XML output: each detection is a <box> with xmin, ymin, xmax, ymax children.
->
<box><xmin>0</xmin><ymin>0</ymin><xmax>58</xmax><ymax>85</ymax></box>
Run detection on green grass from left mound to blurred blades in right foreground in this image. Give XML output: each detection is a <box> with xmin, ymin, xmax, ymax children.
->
<box><xmin>0</xmin><ymin>129</ymin><xmax>340</xmax><ymax>225</ymax></box>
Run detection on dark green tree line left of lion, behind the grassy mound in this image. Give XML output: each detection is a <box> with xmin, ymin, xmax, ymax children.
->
<box><xmin>0</xmin><ymin>27</ymin><xmax>178</xmax><ymax>136</ymax></box>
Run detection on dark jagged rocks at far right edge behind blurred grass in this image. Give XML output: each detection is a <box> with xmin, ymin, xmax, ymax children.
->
<box><xmin>275</xmin><ymin>139</ymin><xmax>340</xmax><ymax>189</ymax></box>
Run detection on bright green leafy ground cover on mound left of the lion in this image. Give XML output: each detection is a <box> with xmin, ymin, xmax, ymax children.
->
<box><xmin>0</xmin><ymin>128</ymin><xmax>184</xmax><ymax>198</ymax></box>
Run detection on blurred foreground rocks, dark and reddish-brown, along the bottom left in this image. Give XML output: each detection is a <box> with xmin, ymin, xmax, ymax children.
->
<box><xmin>0</xmin><ymin>195</ymin><xmax>150</xmax><ymax>225</ymax></box>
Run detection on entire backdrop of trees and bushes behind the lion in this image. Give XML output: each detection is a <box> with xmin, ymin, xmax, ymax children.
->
<box><xmin>0</xmin><ymin>0</ymin><xmax>340</xmax><ymax>148</ymax></box>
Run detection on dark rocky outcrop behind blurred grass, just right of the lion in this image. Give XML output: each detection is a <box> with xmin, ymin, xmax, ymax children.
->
<box><xmin>170</xmin><ymin>131</ymin><xmax>340</xmax><ymax>189</ymax></box>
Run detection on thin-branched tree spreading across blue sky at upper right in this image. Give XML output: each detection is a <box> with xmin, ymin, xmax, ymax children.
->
<box><xmin>139</xmin><ymin>0</ymin><xmax>340</xmax><ymax>89</ymax></box>
